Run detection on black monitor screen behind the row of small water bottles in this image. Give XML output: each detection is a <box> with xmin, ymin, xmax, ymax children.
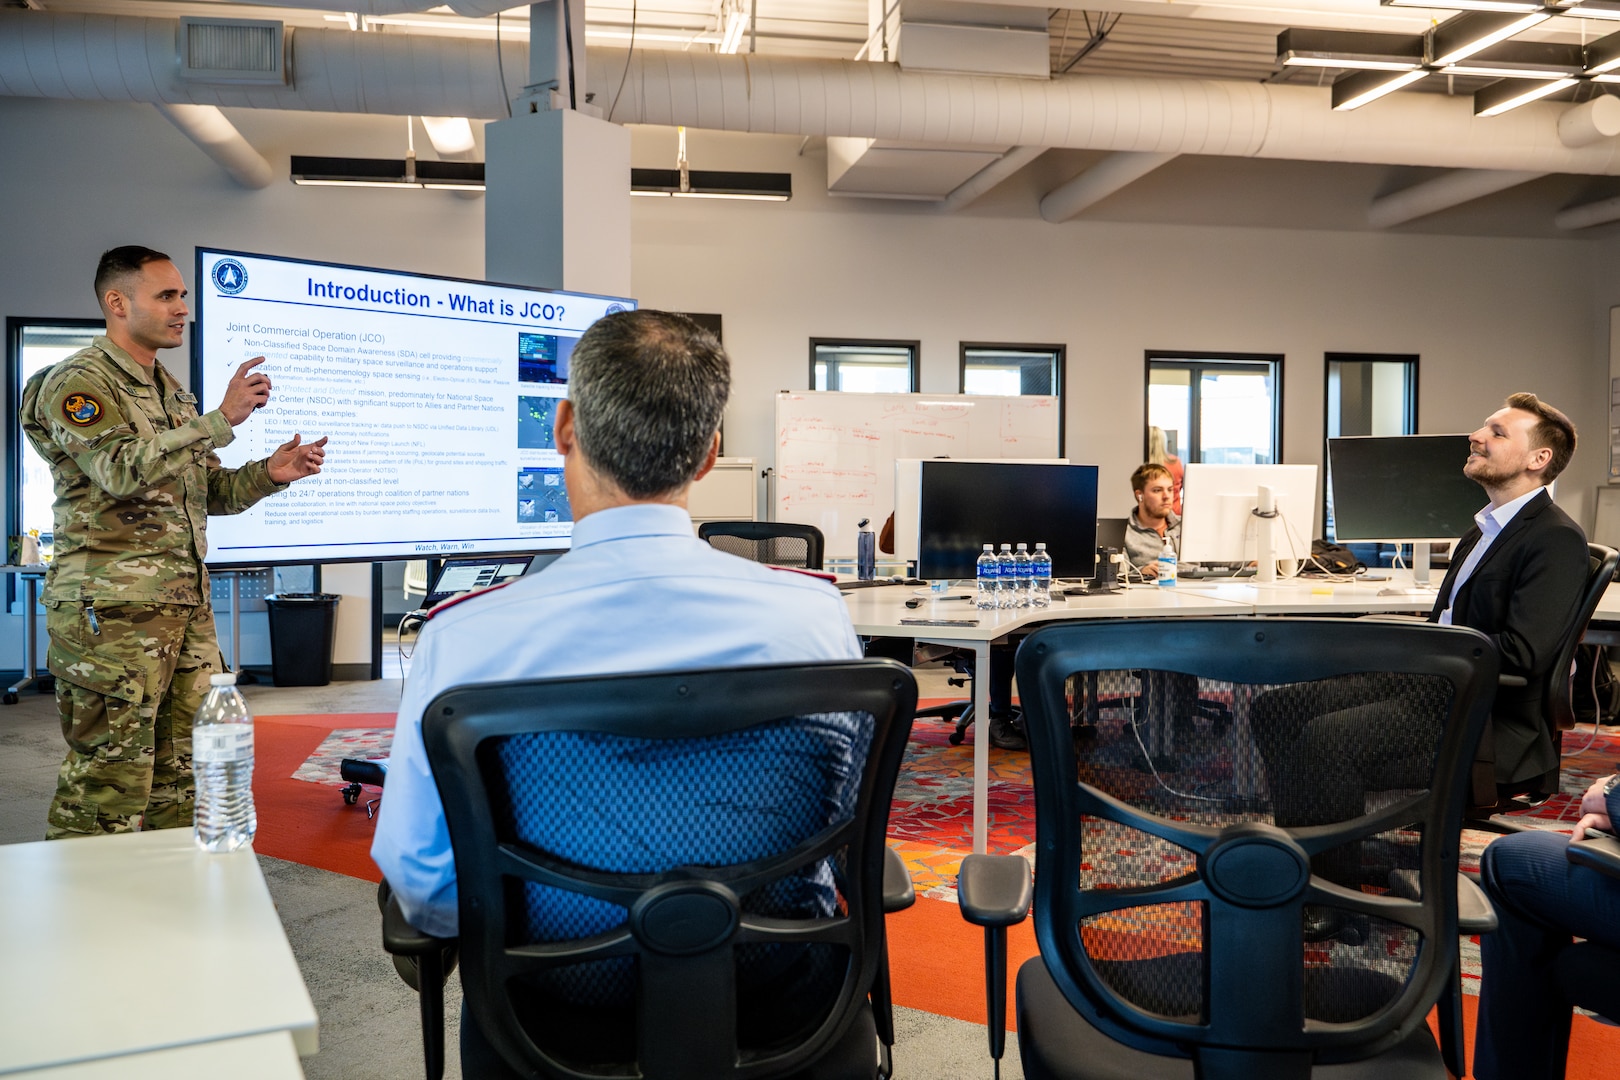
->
<box><xmin>917</xmin><ymin>461</ymin><xmax>1097</xmax><ymax>580</ymax></box>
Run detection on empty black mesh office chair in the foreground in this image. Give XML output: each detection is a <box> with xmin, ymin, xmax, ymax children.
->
<box><xmin>957</xmin><ymin>619</ymin><xmax>1497</xmax><ymax>1080</ymax></box>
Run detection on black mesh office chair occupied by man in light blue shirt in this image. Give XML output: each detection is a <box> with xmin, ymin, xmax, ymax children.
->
<box><xmin>375</xmin><ymin>661</ymin><xmax>917</xmax><ymax>1080</ymax></box>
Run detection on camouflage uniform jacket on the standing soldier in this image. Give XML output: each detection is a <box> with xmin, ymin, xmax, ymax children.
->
<box><xmin>19</xmin><ymin>337</ymin><xmax>285</xmax><ymax>606</ymax></box>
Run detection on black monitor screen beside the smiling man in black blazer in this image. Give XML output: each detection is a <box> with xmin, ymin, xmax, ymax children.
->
<box><xmin>1327</xmin><ymin>436</ymin><xmax>1489</xmax><ymax>542</ymax></box>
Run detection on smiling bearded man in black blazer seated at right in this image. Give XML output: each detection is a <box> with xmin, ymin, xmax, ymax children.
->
<box><xmin>1429</xmin><ymin>393</ymin><xmax>1588</xmax><ymax>793</ymax></box>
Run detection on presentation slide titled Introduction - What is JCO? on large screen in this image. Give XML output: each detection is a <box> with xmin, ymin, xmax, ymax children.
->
<box><xmin>191</xmin><ymin>248</ymin><xmax>635</xmax><ymax>567</ymax></box>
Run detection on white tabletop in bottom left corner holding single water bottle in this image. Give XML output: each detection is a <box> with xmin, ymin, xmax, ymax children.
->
<box><xmin>0</xmin><ymin>829</ymin><xmax>319</xmax><ymax>1074</ymax></box>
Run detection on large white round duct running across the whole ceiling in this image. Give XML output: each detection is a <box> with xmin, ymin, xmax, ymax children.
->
<box><xmin>0</xmin><ymin>11</ymin><xmax>1620</xmax><ymax>175</ymax></box>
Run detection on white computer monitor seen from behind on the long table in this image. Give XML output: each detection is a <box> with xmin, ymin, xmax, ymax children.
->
<box><xmin>1181</xmin><ymin>463</ymin><xmax>1315</xmax><ymax>581</ymax></box>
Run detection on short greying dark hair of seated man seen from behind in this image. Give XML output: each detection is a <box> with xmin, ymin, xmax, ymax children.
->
<box><xmin>569</xmin><ymin>311</ymin><xmax>731</xmax><ymax>499</ymax></box>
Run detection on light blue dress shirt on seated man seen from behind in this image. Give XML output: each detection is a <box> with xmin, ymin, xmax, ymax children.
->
<box><xmin>371</xmin><ymin>504</ymin><xmax>862</xmax><ymax>938</ymax></box>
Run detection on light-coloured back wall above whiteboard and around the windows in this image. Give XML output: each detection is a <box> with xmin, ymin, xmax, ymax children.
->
<box><xmin>0</xmin><ymin>99</ymin><xmax>1620</xmax><ymax>665</ymax></box>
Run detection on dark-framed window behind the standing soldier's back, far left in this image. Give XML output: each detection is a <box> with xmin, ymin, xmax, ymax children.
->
<box><xmin>5</xmin><ymin>317</ymin><xmax>107</xmax><ymax>614</ymax></box>
